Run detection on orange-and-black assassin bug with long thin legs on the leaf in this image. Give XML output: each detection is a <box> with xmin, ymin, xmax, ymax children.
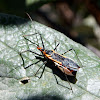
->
<box><xmin>20</xmin><ymin>15</ymin><xmax>80</xmax><ymax>90</ymax></box>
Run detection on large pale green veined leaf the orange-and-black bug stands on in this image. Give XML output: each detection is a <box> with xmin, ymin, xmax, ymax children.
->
<box><xmin>0</xmin><ymin>14</ymin><xmax>100</xmax><ymax>100</ymax></box>
